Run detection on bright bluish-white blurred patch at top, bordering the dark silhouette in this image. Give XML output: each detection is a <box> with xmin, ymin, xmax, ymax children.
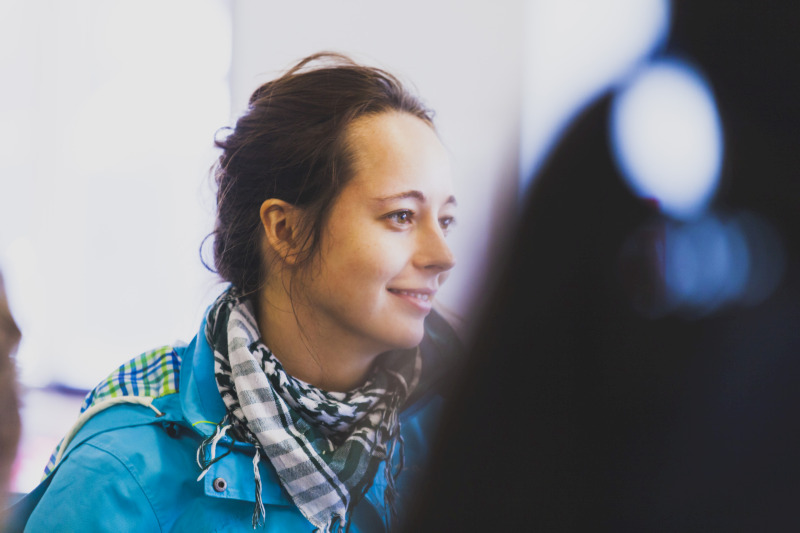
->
<box><xmin>520</xmin><ymin>0</ymin><xmax>670</xmax><ymax>186</ymax></box>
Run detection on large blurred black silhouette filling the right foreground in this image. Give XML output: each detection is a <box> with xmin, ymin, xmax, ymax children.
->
<box><xmin>407</xmin><ymin>0</ymin><xmax>800</xmax><ymax>532</ymax></box>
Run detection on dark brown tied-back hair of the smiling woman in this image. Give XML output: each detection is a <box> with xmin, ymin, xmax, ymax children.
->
<box><xmin>203</xmin><ymin>52</ymin><xmax>433</xmax><ymax>295</ymax></box>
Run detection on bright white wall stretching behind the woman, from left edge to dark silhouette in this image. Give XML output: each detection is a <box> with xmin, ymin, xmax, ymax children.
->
<box><xmin>0</xmin><ymin>0</ymin><xmax>666</xmax><ymax>387</ymax></box>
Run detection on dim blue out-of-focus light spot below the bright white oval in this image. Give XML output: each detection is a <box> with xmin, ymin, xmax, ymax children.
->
<box><xmin>620</xmin><ymin>212</ymin><xmax>785</xmax><ymax>318</ymax></box>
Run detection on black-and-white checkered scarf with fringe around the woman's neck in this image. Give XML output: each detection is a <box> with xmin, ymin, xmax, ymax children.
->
<box><xmin>206</xmin><ymin>288</ymin><xmax>422</xmax><ymax>532</ymax></box>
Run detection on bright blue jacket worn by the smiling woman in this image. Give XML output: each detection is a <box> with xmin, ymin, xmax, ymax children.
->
<box><xmin>7</xmin><ymin>313</ymin><xmax>458</xmax><ymax>533</ymax></box>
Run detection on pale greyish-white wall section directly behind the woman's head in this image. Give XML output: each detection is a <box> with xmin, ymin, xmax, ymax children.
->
<box><xmin>231</xmin><ymin>0</ymin><xmax>524</xmax><ymax>312</ymax></box>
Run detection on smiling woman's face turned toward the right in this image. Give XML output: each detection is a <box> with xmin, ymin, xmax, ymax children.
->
<box><xmin>295</xmin><ymin>112</ymin><xmax>456</xmax><ymax>354</ymax></box>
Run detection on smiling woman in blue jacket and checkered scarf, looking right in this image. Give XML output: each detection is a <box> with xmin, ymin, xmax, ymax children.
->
<box><xmin>9</xmin><ymin>54</ymin><xmax>458</xmax><ymax>531</ymax></box>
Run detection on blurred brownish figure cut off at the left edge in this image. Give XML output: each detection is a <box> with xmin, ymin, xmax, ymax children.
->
<box><xmin>0</xmin><ymin>274</ymin><xmax>20</xmax><ymax>504</ymax></box>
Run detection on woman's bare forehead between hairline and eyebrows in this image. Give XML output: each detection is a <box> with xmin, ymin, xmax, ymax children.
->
<box><xmin>348</xmin><ymin>112</ymin><xmax>452</xmax><ymax>196</ymax></box>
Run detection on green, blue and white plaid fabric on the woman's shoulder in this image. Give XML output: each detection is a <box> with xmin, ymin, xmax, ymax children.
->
<box><xmin>44</xmin><ymin>346</ymin><xmax>181</xmax><ymax>477</ymax></box>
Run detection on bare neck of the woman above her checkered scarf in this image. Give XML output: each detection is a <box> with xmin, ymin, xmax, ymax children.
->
<box><xmin>256</xmin><ymin>285</ymin><xmax>381</xmax><ymax>392</ymax></box>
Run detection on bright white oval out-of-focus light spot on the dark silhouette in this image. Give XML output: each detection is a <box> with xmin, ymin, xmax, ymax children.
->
<box><xmin>611</xmin><ymin>59</ymin><xmax>723</xmax><ymax>220</ymax></box>
